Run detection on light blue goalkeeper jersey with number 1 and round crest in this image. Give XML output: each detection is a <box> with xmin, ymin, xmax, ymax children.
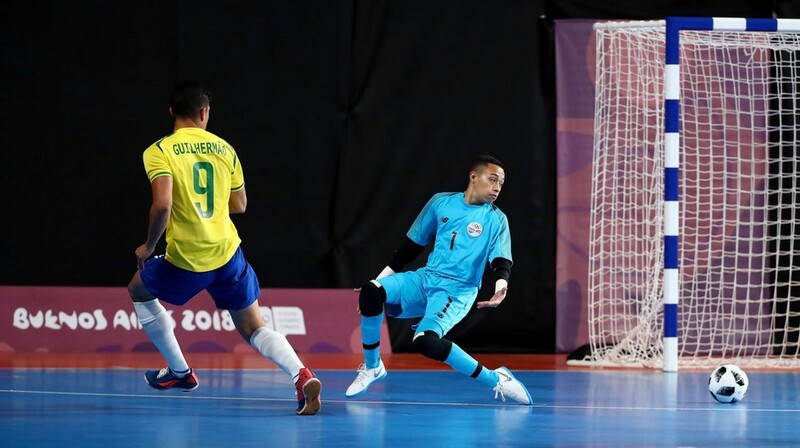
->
<box><xmin>406</xmin><ymin>192</ymin><xmax>512</xmax><ymax>288</ymax></box>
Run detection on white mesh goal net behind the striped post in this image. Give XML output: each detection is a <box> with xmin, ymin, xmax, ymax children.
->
<box><xmin>571</xmin><ymin>19</ymin><xmax>800</xmax><ymax>368</ymax></box>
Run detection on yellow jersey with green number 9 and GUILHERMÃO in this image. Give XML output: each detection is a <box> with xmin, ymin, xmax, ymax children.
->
<box><xmin>143</xmin><ymin>128</ymin><xmax>244</xmax><ymax>272</ymax></box>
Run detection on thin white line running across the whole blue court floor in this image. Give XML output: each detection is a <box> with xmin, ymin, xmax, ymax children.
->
<box><xmin>0</xmin><ymin>389</ymin><xmax>800</xmax><ymax>413</ymax></box>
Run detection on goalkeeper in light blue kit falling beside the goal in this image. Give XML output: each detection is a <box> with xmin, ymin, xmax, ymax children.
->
<box><xmin>345</xmin><ymin>155</ymin><xmax>532</xmax><ymax>405</ymax></box>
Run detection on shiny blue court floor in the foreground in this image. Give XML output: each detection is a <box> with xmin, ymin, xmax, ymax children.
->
<box><xmin>0</xmin><ymin>368</ymin><xmax>800</xmax><ymax>448</ymax></box>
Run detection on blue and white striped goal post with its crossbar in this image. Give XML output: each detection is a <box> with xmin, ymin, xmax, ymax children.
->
<box><xmin>663</xmin><ymin>17</ymin><xmax>800</xmax><ymax>372</ymax></box>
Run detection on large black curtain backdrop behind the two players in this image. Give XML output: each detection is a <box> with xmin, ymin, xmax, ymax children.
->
<box><xmin>0</xmin><ymin>0</ymin><xmax>788</xmax><ymax>353</ymax></box>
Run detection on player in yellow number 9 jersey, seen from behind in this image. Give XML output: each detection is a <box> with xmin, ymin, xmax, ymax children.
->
<box><xmin>128</xmin><ymin>82</ymin><xmax>322</xmax><ymax>415</ymax></box>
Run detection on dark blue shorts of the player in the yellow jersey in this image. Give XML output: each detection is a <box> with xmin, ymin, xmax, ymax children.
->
<box><xmin>140</xmin><ymin>247</ymin><xmax>261</xmax><ymax>310</ymax></box>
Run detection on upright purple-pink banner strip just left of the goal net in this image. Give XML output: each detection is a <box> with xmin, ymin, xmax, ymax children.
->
<box><xmin>555</xmin><ymin>20</ymin><xmax>595</xmax><ymax>353</ymax></box>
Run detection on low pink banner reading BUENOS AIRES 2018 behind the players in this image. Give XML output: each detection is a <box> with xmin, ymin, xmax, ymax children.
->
<box><xmin>0</xmin><ymin>286</ymin><xmax>391</xmax><ymax>353</ymax></box>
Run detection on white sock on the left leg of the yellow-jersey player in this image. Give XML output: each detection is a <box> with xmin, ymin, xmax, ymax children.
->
<box><xmin>133</xmin><ymin>300</ymin><xmax>189</xmax><ymax>372</ymax></box>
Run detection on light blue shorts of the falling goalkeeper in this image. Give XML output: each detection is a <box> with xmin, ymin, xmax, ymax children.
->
<box><xmin>377</xmin><ymin>268</ymin><xmax>478</xmax><ymax>337</ymax></box>
